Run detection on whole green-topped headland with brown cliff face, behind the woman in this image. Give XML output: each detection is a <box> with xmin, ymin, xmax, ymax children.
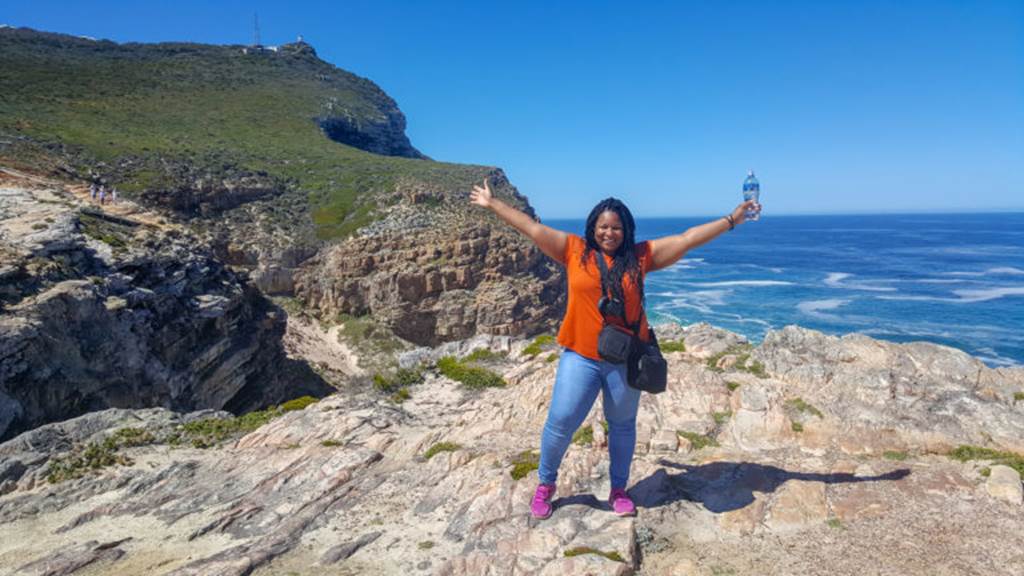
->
<box><xmin>0</xmin><ymin>28</ymin><xmax>560</xmax><ymax>344</ymax></box>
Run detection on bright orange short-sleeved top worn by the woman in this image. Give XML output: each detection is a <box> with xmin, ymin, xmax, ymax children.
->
<box><xmin>558</xmin><ymin>234</ymin><xmax>651</xmax><ymax>360</ymax></box>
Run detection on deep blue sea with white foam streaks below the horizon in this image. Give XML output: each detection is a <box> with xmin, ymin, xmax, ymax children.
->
<box><xmin>546</xmin><ymin>213</ymin><xmax>1024</xmax><ymax>366</ymax></box>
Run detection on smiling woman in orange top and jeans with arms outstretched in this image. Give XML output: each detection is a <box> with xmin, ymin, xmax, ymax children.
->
<box><xmin>469</xmin><ymin>178</ymin><xmax>761</xmax><ymax>519</ymax></box>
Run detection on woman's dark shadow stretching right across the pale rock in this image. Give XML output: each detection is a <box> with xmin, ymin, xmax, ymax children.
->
<box><xmin>630</xmin><ymin>459</ymin><xmax>910</xmax><ymax>513</ymax></box>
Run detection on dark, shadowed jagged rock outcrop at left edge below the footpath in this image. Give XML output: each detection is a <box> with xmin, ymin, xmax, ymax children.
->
<box><xmin>0</xmin><ymin>170</ymin><xmax>329</xmax><ymax>438</ymax></box>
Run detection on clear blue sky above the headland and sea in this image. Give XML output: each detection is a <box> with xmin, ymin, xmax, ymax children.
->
<box><xmin>0</xmin><ymin>0</ymin><xmax>1024</xmax><ymax>218</ymax></box>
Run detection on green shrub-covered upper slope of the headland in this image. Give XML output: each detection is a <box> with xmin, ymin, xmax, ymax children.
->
<box><xmin>0</xmin><ymin>29</ymin><xmax>487</xmax><ymax>238</ymax></box>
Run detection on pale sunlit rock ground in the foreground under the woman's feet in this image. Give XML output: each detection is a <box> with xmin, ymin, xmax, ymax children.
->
<box><xmin>0</xmin><ymin>325</ymin><xmax>1024</xmax><ymax>576</ymax></box>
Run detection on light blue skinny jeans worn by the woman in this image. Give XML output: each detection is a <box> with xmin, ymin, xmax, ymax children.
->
<box><xmin>538</xmin><ymin>348</ymin><xmax>640</xmax><ymax>488</ymax></box>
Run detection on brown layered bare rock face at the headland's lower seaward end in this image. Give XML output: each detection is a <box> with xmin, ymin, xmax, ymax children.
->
<box><xmin>295</xmin><ymin>170</ymin><xmax>564</xmax><ymax>345</ymax></box>
